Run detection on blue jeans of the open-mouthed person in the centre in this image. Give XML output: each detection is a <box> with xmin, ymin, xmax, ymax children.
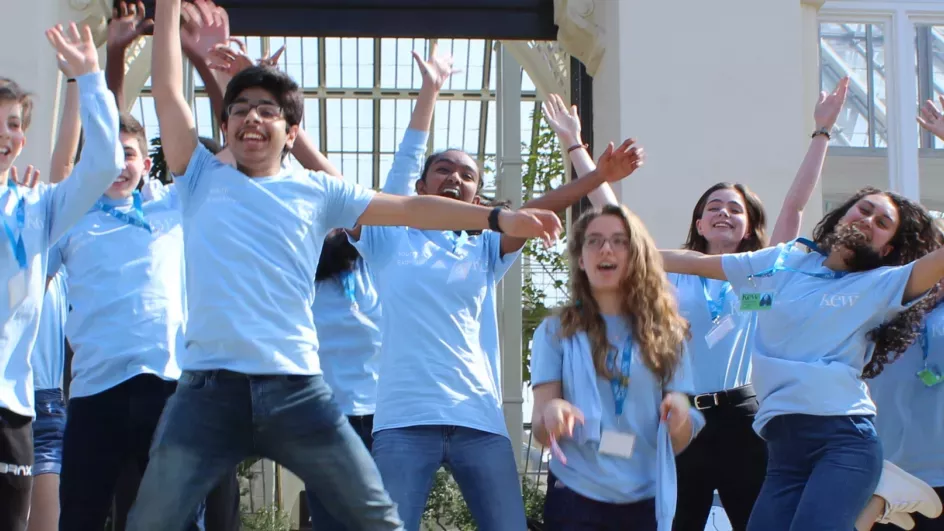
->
<box><xmin>373</xmin><ymin>426</ymin><xmax>527</xmax><ymax>531</ymax></box>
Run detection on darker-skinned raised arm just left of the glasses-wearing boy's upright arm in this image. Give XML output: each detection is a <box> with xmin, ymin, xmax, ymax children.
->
<box><xmin>105</xmin><ymin>2</ymin><xmax>154</xmax><ymax>110</ymax></box>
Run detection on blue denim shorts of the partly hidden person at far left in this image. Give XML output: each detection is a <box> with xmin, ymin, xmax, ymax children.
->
<box><xmin>33</xmin><ymin>389</ymin><xmax>66</xmax><ymax>477</ymax></box>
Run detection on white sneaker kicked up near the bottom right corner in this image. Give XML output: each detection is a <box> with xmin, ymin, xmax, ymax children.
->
<box><xmin>875</xmin><ymin>461</ymin><xmax>944</xmax><ymax>529</ymax></box>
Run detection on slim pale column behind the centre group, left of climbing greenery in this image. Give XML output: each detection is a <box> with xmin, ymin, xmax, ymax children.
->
<box><xmin>496</xmin><ymin>46</ymin><xmax>524</xmax><ymax>469</ymax></box>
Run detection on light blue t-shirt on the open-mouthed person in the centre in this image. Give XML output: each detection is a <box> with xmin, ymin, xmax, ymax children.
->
<box><xmin>355</xmin><ymin>227</ymin><xmax>520</xmax><ymax>436</ymax></box>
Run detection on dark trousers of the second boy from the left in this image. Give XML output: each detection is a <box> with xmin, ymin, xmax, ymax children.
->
<box><xmin>59</xmin><ymin>375</ymin><xmax>198</xmax><ymax>531</ymax></box>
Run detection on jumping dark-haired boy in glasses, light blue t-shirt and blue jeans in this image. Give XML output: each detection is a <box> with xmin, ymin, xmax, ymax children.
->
<box><xmin>128</xmin><ymin>0</ymin><xmax>560</xmax><ymax>531</ymax></box>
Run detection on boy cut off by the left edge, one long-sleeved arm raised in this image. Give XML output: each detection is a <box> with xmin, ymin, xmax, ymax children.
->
<box><xmin>0</xmin><ymin>24</ymin><xmax>122</xmax><ymax>531</ymax></box>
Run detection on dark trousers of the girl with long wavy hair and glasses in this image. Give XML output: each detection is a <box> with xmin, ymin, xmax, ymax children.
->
<box><xmin>542</xmin><ymin>473</ymin><xmax>657</xmax><ymax>531</ymax></box>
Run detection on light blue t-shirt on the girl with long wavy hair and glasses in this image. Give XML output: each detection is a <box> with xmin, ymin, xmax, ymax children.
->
<box><xmin>531</xmin><ymin>315</ymin><xmax>704</xmax><ymax>503</ymax></box>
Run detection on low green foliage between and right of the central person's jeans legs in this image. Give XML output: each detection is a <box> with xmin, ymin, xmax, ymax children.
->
<box><xmin>423</xmin><ymin>469</ymin><xmax>544</xmax><ymax>531</ymax></box>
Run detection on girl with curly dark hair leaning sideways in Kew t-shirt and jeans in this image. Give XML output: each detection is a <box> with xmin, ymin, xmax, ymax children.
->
<box><xmin>663</xmin><ymin>188</ymin><xmax>944</xmax><ymax>531</ymax></box>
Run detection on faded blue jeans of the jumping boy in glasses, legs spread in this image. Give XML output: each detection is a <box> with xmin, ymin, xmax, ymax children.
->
<box><xmin>127</xmin><ymin>370</ymin><xmax>402</xmax><ymax>531</ymax></box>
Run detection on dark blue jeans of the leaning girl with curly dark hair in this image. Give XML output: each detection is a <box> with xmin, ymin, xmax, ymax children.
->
<box><xmin>747</xmin><ymin>415</ymin><xmax>882</xmax><ymax>531</ymax></box>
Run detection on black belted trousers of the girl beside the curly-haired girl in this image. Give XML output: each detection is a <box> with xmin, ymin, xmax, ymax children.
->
<box><xmin>672</xmin><ymin>388</ymin><xmax>767</xmax><ymax>531</ymax></box>
